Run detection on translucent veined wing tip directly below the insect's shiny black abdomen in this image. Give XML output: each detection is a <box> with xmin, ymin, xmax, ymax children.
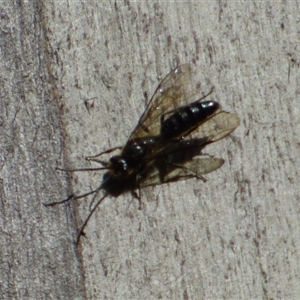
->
<box><xmin>187</xmin><ymin>111</ymin><xmax>240</xmax><ymax>144</ymax></box>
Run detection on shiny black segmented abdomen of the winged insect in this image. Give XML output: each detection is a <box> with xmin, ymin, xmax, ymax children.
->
<box><xmin>161</xmin><ymin>101</ymin><xmax>220</xmax><ymax>139</ymax></box>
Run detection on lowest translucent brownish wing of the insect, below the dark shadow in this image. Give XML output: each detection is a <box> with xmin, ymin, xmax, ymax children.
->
<box><xmin>140</xmin><ymin>156</ymin><xmax>224</xmax><ymax>187</ymax></box>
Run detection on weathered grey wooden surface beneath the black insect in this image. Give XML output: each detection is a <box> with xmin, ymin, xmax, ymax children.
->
<box><xmin>0</xmin><ymin>1</ymin><xmax>300</xmax><ymax>299</ymax></box>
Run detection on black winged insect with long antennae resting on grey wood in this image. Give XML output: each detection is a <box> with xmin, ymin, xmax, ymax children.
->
<box><xmin>45</xmin><ymin>64</ymin><xmax>240</xmax><ymax>243</ymax></box>
